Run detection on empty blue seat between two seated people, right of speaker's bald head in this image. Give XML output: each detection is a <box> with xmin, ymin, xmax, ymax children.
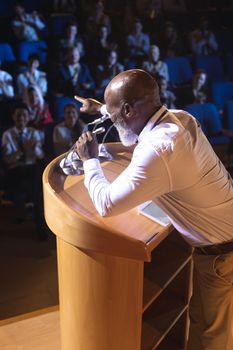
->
<box><xmin>164</xmin><ymin>56</ymin><xmax>193</xmax><ymax>85</ymax></box>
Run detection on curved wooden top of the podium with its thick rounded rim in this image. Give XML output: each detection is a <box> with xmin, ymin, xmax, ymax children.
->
<box><xmin>43</xmin><ymin>143</ymin><xmax>172</xmax><ymax>261</ymax></box>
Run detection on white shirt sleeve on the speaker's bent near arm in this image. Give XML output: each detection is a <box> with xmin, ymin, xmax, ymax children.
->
<box><xmin>83</xmin><ymin>144</ymin><xmax>171</xmax><ymax>216</ymax></box>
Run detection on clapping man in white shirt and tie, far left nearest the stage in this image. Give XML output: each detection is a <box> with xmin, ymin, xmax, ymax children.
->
<box><xmin>2</xmin><ymin>103</ymin><xmax>44</xmax><ymax>235</ymax></box>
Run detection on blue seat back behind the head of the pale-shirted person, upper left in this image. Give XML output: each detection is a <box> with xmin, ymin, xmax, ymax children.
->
<box><xmin>18</xmin><ymin>40</ymin><xmax>48</xmax><ymax>64</ymax></box>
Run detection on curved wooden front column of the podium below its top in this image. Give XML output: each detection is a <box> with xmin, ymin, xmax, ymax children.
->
<box><xmin>58</xmin><ymin>240</ymin><xmax>143</xmax><ymax>350</ymax></box>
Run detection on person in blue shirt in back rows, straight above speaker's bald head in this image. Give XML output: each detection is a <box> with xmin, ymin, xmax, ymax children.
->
<box><xmin>126</xmin><ymin>19</ymin><xmax>150</xmax><ymax>60</ymax></box>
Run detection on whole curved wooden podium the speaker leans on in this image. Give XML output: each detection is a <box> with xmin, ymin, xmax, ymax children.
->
<box><xmin>43</xmin><ymin>143</ymin><xmax>192</xmax><ymax>350</ymax></box>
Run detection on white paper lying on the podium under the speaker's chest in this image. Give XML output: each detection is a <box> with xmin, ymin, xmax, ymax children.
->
<box><xmin>138</xmin><ymin>201</ymin><xmax>171</xmax><ymax>226</ymax></box>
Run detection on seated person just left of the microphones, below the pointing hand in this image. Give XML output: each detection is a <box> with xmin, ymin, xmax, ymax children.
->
<box><xmin>53</xmin><ymin>103</ymin><xmax>85</xmax><ymax>156</ymax></box>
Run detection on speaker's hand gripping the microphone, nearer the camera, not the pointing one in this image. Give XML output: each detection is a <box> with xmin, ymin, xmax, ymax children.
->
<box><xmin>76</xmin><ymin>131</ymin><xmax>99</xmax><ymax>161</ymax></box>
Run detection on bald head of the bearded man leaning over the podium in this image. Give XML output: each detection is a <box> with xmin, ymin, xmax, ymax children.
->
<box><xmin>104</xmin><ymin>69</ymin><xmax>161</xmax><ymax>139</ymax></box>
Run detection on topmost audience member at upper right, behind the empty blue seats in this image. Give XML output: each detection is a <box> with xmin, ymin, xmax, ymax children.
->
<box><xmin>188</xmin><ymin>17</ymin><xmax>218</xmax><ymax>55</ymax></box>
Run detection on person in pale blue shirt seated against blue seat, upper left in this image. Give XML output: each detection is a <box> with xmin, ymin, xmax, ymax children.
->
<box><xmin>17</xmin><ymin>54</ymin><xmax>48</xmax><ymax>96</ymax></box>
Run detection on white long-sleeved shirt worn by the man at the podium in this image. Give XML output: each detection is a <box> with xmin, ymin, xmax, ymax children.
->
<box><xmin>84</xmin><ymin>106</ymin><xmax>233</xmax><ymax>246</ymax></box>
